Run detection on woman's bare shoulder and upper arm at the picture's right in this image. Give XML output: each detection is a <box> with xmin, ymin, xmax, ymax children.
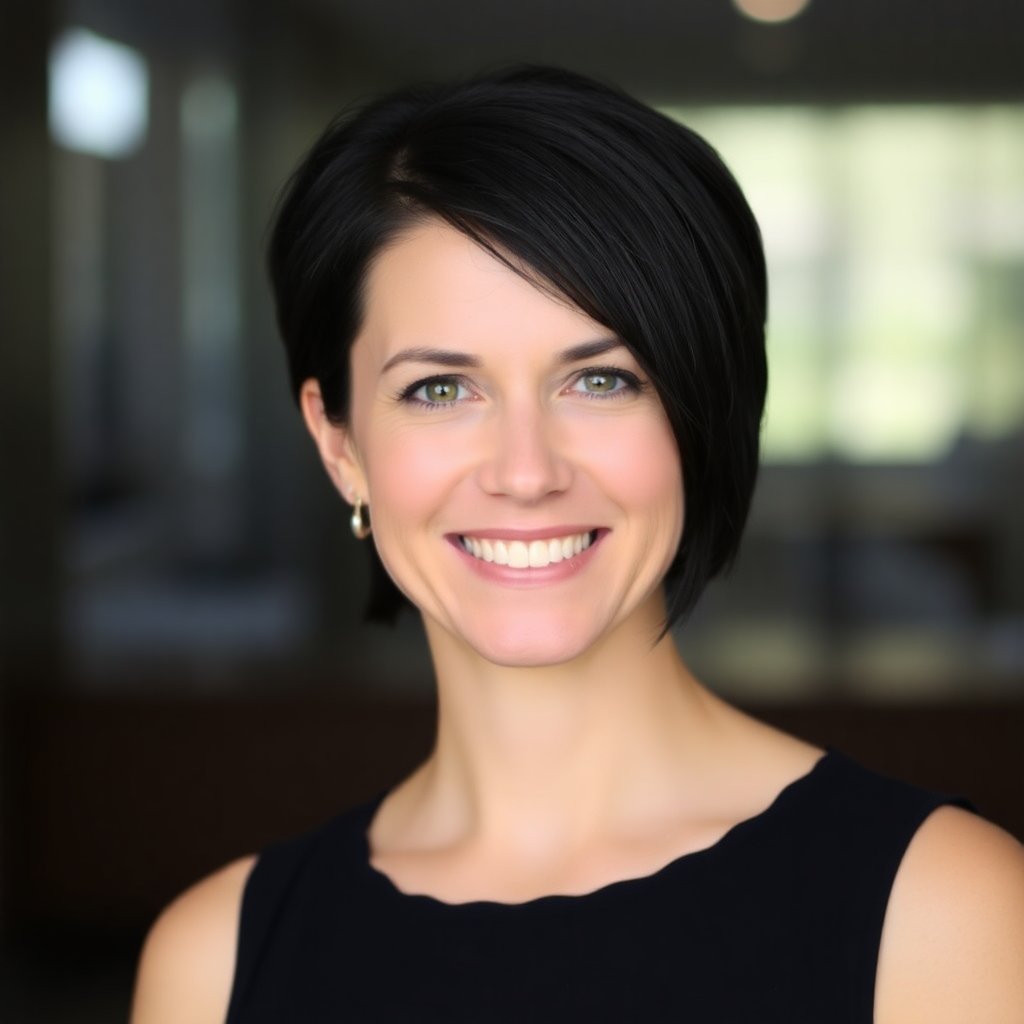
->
<box><xmin>876</xmin><ymin>807</ymin><xmax>1024</xmax><ymax>1024</ymax></box>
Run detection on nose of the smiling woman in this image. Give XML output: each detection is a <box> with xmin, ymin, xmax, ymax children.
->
<box><xmin>480</xmin><ymin>401</ymin><xmax>572</xmax><ymax>504</ymax></box>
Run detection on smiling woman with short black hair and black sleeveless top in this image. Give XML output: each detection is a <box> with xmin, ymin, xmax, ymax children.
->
<box><xmin>133</xmin><ymin>69</ymin><xmax>1024</xmax><ymax>1024</ymax></box>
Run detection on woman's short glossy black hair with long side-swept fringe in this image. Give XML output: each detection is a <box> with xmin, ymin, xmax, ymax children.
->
<box><xmin>269</xmin><ymin>67</ymin><xmax>767</xmax><ymax>624</ymax></box>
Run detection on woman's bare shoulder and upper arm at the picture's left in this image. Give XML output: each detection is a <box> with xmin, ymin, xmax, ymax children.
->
<box><xmin>131</xmin><ymin>857</ymin><xmax>256</xmax><ymax>1024</ymax></box>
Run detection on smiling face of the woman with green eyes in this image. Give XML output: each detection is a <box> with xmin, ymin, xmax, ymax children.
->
<box><xmin>307</xmin><ymin>221</ymin><xmax>683</xmax><ymax>666</ymax></box>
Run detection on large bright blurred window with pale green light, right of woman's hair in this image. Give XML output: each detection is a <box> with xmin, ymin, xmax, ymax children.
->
<box><xmin>667</xmin><ymin>105</ymin><xmax>1024</xmax><ymax>463</ymax></box>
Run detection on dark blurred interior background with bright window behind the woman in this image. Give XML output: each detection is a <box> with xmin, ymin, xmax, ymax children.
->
<box><xmin>0</xmin><ymin>0</ymin><xmax>1024</xmax><ymax>1024</ymax></box>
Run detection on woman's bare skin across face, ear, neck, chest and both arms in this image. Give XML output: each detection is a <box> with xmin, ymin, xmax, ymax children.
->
<box><xmin>132</xmin><ymin>221</ymin><xmax>1024</xmax><ymax>1024</ymax></box>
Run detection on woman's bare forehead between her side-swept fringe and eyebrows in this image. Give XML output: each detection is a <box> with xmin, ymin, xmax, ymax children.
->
<box><xmin>357</xmin><ymin>220</ymin><xmax>608</xmax><ymax>359</ymax></box>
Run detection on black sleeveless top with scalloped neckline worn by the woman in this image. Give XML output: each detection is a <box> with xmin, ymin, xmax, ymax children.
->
<box><xmin>227</xmin><ymin>753</ymin><xmax>966</xmax><ymax>1024</ymax></box>
